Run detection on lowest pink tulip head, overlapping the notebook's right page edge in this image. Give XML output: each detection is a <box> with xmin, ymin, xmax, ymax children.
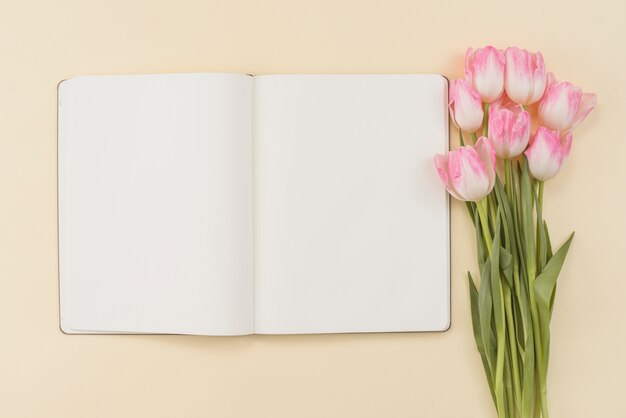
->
<box><xmin>435</xmin><ymin>137</ymin><xmax>496</xmax><ymax>202</ymax></box>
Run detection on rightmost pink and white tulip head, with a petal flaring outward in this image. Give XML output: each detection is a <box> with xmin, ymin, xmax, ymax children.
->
<box><xmin>539</xmin><ymin>73</ymin><xmax>596</xmax><ymax>132</ymax></box>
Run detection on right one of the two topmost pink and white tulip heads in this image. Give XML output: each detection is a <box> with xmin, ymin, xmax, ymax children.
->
<box><xmin>504</xmin><ymin>48</ymin><xmax>546</xmax><ymax>105</ymax></box>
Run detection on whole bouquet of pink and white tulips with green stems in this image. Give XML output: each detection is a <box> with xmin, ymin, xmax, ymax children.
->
<box><xmin>435</xmin><ymin>46</ymin><xmax>596</xmax><ymax>418</ymax></box>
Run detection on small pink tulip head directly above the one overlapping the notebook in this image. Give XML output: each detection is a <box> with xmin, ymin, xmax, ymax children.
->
<box><xmin>449</xmin><ymin>80</ymin><xmax>483</xmax><ymax>132</ymax></box>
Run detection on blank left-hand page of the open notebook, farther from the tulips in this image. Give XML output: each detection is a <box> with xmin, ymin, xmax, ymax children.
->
<box><xmin>58</xmin><ymin>74</ymin><xmax>253</xmax><ymax>335</ymax></box>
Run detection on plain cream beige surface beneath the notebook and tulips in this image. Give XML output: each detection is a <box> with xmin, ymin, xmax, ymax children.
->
<box><xmin>0</xmin><ymin>0</ymin><xmax>626</xmax><ymax>418</ymax></box>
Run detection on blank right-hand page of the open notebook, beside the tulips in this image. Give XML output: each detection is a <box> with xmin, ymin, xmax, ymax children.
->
<box><xmin>253</xmin><ymin>75</ymin><xmax>450</xmax><ymax>334</ymax></box>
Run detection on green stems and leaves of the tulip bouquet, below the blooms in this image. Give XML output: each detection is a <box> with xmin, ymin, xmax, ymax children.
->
<box><xmin>468</xmin><ymin>152</ymin><xmax>573</xmax><ymax>418</ymax></box>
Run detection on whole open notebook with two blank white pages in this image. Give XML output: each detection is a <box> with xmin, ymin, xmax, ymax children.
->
<box><xmin>58</xmin><ymin>74</ymin><xmax>450</xmax><ymax>335</ymax></box>
